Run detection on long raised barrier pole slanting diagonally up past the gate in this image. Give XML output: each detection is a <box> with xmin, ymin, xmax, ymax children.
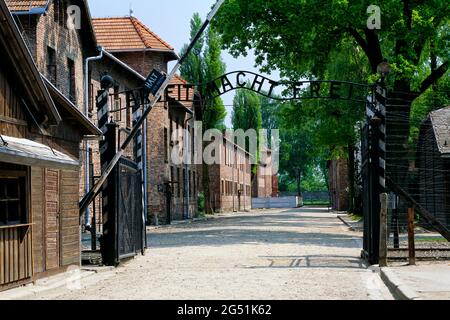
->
<box><xmin>80</xmin><ymin>0</ymin><xmax>225</xmax><ymax>214</ymax></box>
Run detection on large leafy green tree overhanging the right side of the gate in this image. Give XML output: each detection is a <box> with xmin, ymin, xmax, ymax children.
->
<box><xmin>214</xmin><ymin>0</ymin><xmax>450</xmax><ymax>185</ymax></box>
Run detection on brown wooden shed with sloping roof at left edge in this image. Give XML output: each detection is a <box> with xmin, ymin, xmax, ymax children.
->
<box><xmin>0</xmin><ymin>1</ymin><xmax>100</xmax><ymax>291</ymax></box>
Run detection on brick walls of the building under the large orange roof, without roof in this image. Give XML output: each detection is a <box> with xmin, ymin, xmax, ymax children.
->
<box><xmin>99</xmin><ymin>51</ymin><xmax>198</xmax><ymax>224</ymax></box>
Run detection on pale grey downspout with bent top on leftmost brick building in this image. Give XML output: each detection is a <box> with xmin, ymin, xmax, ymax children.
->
<box><xmin>84</xmin><ymin>47</ymin><xmax>103</xmax><ymax>228</ymax></box>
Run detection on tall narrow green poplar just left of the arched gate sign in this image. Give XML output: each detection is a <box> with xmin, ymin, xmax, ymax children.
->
<box><xmin>180</xmin><ymin>13</ymin><xmax>226</xmax><ymax>214</ymax></box>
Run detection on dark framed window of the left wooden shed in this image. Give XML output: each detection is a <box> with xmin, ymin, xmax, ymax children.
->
<box><xmin>0</xmin><ymin>171</ymin><xmax>28</xmax><ymax>226</ymax></box>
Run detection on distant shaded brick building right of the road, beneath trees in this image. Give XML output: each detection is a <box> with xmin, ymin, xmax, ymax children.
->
<box><xmin>328</xmin><ymin>159</ymin><xmax>349</xmax><ymax>211</ymax></box>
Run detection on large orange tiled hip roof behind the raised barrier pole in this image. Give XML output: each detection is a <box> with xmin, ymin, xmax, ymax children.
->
<box><xmin>93</xmin><ymin>17</ymin><xmax>174</xmax><ymax>52</ymax></box>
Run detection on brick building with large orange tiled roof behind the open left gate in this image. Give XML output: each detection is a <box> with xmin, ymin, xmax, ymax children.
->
<box><xmin>93</xmin><ymin>16</ymin><xmax>199</xmax><ymax>224</ymax></box>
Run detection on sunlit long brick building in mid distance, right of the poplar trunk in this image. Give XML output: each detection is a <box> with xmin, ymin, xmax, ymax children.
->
<box><xmin>209</xmin><ymin>137</ymin><xmax>252</xmax><ymax>212</ymax></box>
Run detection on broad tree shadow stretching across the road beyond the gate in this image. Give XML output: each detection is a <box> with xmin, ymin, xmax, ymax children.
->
<box><xmin>148</xmin><ymin>208</ymin><xmax>359</xmax><ymax>248</ymax></box>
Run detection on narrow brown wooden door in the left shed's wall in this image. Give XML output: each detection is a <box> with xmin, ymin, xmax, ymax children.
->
<box><xmin>44</xmin><ymin>170</ymin><xmax>60</xmax><ymax>270</ymax></box>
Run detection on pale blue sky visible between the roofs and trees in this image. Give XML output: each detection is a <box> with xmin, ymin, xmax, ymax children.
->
<box><xmin>88</xmin><ymin>0</ymin><xmax>279</xmax><ymax>127</ymax></box>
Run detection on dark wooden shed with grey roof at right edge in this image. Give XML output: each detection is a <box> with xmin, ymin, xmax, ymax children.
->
<box><xmin>413</xmin><ymin>107</ymin><xmax>450</xmax><ymax>228</ymax></box>
